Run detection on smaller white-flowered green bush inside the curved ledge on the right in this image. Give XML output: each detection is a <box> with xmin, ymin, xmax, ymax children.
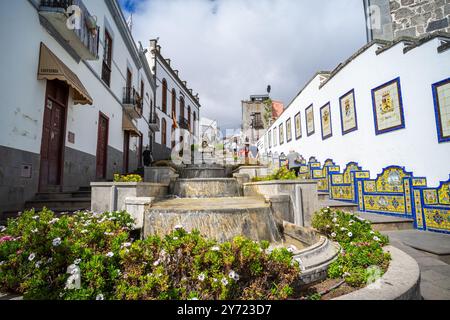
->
<box><xmin>312</xmin><ymin>208</ymin><xmax>390</xmax><ymax>287</ymax></box>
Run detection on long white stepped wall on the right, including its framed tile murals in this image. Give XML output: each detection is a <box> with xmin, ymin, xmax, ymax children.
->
<box><xmin>260</xmin><ymin>33</ymin><xmax>450</xmax><ymax>186</ymax></box>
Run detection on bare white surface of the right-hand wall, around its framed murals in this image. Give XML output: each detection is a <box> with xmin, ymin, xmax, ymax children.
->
<box><xmin>260</xmin><ymin>37</ymin><xmax>450</xmax><ymax>186</ymax></box>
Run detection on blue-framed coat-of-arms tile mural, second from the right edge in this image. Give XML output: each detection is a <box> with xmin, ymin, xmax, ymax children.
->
<box><xmin>372</xmin><ymin>78</ymin><xmax>405</xmax><ymax>135</ymax></box>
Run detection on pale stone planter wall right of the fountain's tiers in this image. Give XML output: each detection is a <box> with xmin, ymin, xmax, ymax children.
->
<box><xmin>244</xmin><ymin>180</ymin><xmax>320</xmax><ymax>227</ymax></box>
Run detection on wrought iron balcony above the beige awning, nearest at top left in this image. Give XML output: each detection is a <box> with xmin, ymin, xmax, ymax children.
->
<box><xmin>39</xmin><ymin>0</ymin><xmax>100</xmax><ymax>60</ymax></box>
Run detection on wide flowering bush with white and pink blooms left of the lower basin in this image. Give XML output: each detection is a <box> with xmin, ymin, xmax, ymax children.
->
<box><xmin>0</xmin><ymin>209</ymin><xmax>299</xmax><ymax>299</ymax></box>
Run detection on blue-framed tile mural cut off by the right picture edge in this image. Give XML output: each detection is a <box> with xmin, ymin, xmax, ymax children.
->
<box><xmin>433</xmin><ymin>78</ymin><xmax>450</xmax><ymax>142</ymax></box>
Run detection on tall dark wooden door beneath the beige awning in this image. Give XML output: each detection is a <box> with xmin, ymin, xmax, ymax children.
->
<box><xmin>39</xmin><ymin>80</ymin><xmax>68</xmax><ymax>191</ymax></box>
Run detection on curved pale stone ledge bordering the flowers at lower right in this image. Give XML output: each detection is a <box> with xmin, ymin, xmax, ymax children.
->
<box><xmin>333</xmin><ymin>246</ymin><xmax>422</xmax><ymax>300</ymax></box>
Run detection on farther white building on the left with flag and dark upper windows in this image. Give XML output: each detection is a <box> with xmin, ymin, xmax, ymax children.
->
<box><xmin>146</xmin><ymin>40</ymin><xmax>200</xmax><ymax>160</ymax></box>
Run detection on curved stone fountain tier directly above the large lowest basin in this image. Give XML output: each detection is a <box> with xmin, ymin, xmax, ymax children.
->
<box><xmin>172</xmin><ymin>178</ymin><xmax>242</xmax><ymax>198</ymax></box>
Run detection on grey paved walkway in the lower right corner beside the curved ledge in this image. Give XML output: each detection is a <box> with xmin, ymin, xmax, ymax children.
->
<box><xmin>383</xmin><ymin>230</ymin><xmax>450</xmax><ymax>300</ymax></box>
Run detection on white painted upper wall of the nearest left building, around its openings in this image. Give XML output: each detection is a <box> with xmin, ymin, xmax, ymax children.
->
<box><xmin>0</xmin><ymin>0</ymin><xmax>153</xmax><ymax>156</ymax></box>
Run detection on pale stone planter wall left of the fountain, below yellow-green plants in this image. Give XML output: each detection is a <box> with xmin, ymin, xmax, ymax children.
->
<box><xmin>91</xmin><ymin>182</ymin><xmax>169</xmax><ymax>212</ymax></box>
